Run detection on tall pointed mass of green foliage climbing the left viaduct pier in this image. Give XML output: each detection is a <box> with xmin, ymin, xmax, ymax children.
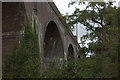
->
<box><xmin>3</xmin><ymin>17</ymin><xmax>41</xmax><ymax>78</ymax></box>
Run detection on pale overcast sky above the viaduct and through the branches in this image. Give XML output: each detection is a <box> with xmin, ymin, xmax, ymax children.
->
<box><xmin>53</xmin><ymin>0</ymin><xmax>120</xmax><ymax>42</ymax></box>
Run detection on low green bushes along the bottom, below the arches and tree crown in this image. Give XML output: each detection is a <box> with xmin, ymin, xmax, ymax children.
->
<box><xmin>39</xmin><ymin>53</ymin><xmax>118</xmax><ymax>78</ymax></box>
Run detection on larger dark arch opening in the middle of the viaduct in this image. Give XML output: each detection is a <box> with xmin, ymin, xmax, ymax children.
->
<box><xmin>43</xmin><ymin>21</ymin><xmax>64</xmax><ymax>59</ymax></box>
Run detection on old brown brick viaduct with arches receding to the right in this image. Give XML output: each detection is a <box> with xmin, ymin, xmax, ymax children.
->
<box><xmin>2</xmin><ymin>2</ymin><xmax>79</xmax><ymax>63</ymax></box>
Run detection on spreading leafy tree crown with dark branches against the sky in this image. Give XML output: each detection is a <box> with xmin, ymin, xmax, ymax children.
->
<box><xmin>67</xmin><ymin>2</ymin><xmax>118</xmax><ymax>53</ymax></box>
